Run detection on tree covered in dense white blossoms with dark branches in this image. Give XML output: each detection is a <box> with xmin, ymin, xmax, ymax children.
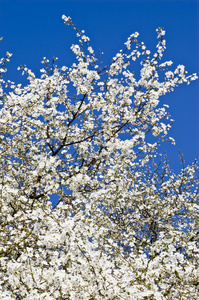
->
<box><xmin>0</xmin><ymin>16</ymin><xmax>199</xmax><ymax>300</ymax></box>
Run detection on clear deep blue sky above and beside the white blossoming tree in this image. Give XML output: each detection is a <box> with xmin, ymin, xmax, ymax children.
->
<box><xmin>0</xmin><ymin>0</ymin><xmax>199</xmax><ymax>170</ymax></box>
